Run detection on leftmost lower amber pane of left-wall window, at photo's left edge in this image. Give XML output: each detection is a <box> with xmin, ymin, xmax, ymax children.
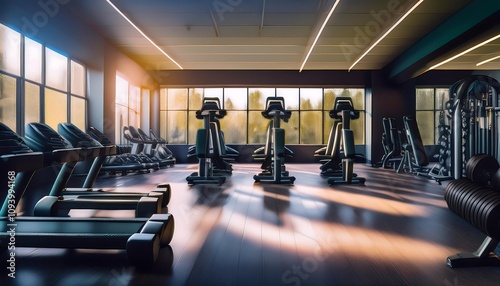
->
<box><xmin>0</xmin><ymin>74</ymin><xmax>17</xmax><ymax>131</ymax></box>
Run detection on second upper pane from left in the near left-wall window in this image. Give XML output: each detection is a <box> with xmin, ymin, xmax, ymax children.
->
<box><xmin>24</xmin><ymin>38</ymin><xmax>42</xmax><ymax>83</ymax></box>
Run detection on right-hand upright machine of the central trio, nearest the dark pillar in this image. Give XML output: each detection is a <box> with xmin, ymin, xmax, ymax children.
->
<box><xmin>314</xmin><ymin>97</ymin><xmax>366</xmax><ymax>185</ymax></box>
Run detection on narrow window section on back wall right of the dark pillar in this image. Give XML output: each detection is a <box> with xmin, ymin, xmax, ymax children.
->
<box><xmin>416</xmin><ymin>88</ymin><xmax>449</xmax><ymax>145</ymax></box>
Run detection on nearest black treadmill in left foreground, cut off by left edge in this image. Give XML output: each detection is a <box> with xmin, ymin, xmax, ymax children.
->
<box><xmin>0</xmin><ymin>123</ymin><xmax>174</xmax><ymax>269</ymax></box>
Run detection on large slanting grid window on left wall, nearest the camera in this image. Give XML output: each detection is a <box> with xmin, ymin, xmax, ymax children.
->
<box><xmin>0</xmin><ymin>24</ymin><xmax>87</xmax><ymax>133</ymax></box>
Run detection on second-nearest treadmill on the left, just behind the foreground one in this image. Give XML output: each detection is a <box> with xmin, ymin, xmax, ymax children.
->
<box><xmin>25</xmin><ymin>123</ymin><xmax>167</xmax><ymax>217</ymax></box>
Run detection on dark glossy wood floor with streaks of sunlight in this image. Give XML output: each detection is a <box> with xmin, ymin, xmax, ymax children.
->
<box><xmin>0</xmin><ymin>164</ymin><xmax>500</xmax><ymax>286</ymax></box>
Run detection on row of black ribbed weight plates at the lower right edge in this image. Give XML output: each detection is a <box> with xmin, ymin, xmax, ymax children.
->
<box><xmin>444</xmin><ymin>179</ymin><xmax>500</xmax><ymax>240</ymax></box>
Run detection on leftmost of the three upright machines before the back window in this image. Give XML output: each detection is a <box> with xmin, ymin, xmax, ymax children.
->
<box><xmin>186</xmin><ymin>97</ymin><xmax>237</xmax><ymax>185</ymax></box>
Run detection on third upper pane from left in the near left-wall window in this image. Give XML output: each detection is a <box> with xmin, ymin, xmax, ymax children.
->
<box><xmin>45</xmin><ymin>48</ymin><xmax>68</xmax><ymax>91</ymax></box>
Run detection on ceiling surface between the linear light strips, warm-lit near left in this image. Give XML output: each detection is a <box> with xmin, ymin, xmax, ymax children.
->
<box><xmin>64</xmin><ymin>0</ymin><xmax>500</xmax><ymax>73</ymax></box>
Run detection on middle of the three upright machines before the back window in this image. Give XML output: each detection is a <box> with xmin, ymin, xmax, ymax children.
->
<box><xmin>253</xmin><ymin>97</ymin><xmax>295</xmax><ymax>184</ymax></box>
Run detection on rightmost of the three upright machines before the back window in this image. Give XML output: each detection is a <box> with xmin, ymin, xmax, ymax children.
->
<box><xmin>322</xmin><ymin>97</ymin><xmax>366</xmax><ymax>185</ymax></box>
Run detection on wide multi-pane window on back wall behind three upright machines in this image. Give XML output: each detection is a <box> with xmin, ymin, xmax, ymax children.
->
<box><xmin>160</xmin><ymin>87</ymin><xmax>365</xmax><ymax>145</ymax></box>
